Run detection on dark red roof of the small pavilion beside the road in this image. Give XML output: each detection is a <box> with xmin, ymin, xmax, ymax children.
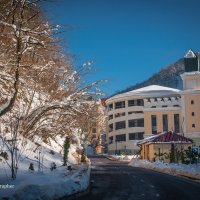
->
<box><xmin>137</xmin><ymin>131</ymin><xmax>193</xmax><ymax>145</ymax></box>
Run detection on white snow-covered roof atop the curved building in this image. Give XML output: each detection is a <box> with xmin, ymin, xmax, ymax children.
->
<box><xmin>110</xmin><ymin>85</ymin><xmax>180</xmax><ymax>100</ymax></box>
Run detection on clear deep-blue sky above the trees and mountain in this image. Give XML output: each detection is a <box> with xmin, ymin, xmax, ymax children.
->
<box><xmin>44</xmin><ymin>0</ymin><xmax>200</xmax><ymax>95</ymax></box>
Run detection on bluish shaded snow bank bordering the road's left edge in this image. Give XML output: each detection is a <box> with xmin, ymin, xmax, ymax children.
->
<box><xmin>12</xmin><ymin>165</ymin><xmax>90</xmax><ymax>200</ymax></box>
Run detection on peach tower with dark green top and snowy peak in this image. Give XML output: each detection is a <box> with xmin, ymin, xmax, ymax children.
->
<box><xmin>181</xmin><ymin>49</ymin><xmax>200</xmax><ymax>145</ymax></box>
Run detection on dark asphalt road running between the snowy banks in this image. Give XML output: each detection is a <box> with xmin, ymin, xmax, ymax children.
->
<box><xmin>78</xmin><ymin>157</ymin><xmax>200</xmax><ymax>200</ymax></box>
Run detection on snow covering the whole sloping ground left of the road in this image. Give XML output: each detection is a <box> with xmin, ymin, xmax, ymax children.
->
<box><xmin>0</xmin><ymin>135</ymin><xmax>90</xmax><ymax>200</ymax></box>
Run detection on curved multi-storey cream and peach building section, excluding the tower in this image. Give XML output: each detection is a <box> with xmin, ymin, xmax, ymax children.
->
<box><xmin>106</xmin><ymin>85</ymin><xmax>181</xmax><ymax>154</ymax></box>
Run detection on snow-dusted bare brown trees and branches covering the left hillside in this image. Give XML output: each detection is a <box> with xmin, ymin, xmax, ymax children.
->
<box><xmin>0</xmin><ymin>0</ymin><xmax>105</xmax><ymax>153</ymax></box>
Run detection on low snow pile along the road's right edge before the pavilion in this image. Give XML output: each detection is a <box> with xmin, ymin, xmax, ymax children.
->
<box><xmin>129</xmin><ymin>158</ymin><xmax>200</xmax><ymax>179</ymax></box>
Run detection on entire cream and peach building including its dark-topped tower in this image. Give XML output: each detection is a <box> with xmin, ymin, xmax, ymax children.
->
<box><xmin>106</xmin><ymin>50</ymin><xmax>200</xmax><ymax>154</ymax></box>
